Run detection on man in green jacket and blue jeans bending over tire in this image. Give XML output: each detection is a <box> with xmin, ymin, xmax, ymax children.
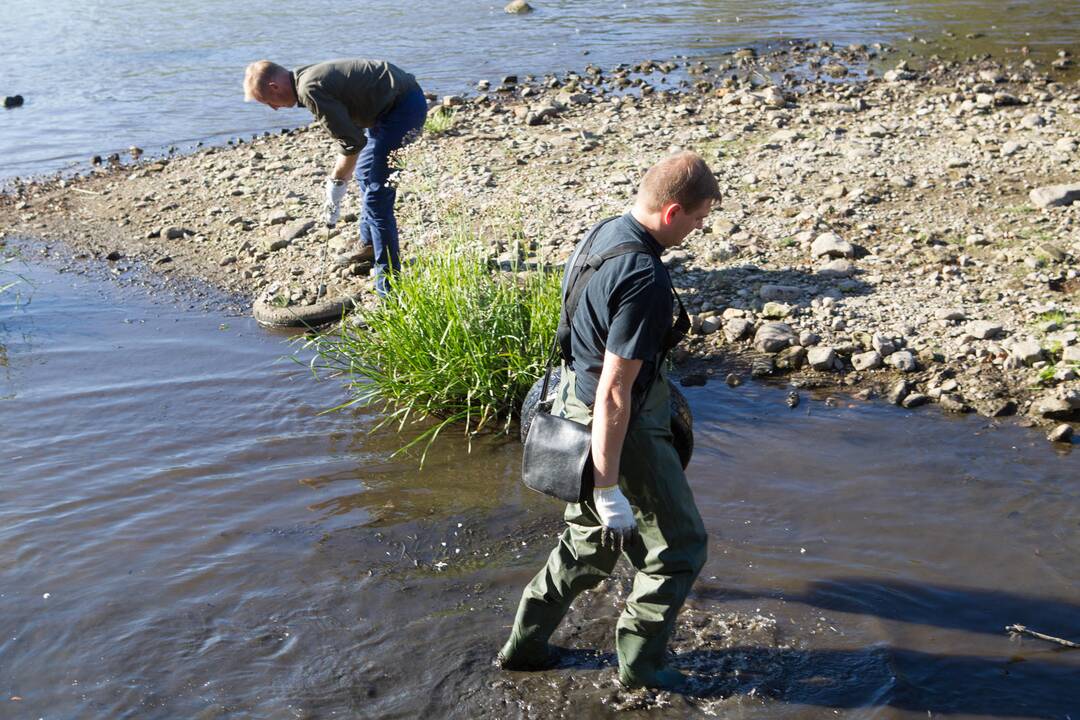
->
<box><xmin>244</xmin><ymin>59</ymin><xmax>428</xmax><ymax>295</ymax></box>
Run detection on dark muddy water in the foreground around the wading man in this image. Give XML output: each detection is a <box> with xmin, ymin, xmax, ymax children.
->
<box><xmin>0</xmin><ymin>260</ymin><xmax>1080</xmax><ymax>719</ymax></box>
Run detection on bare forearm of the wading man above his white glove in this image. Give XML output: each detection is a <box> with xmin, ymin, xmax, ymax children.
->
<box><xmin>593</xmin><ymin>352</ymin><xmax>642</xmax><ymax>488</ymax></box>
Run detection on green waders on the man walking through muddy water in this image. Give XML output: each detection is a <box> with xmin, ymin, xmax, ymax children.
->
<box><xmin>500</xmin><ymin>366</ymin><xmax>707</xmax><ymax>685</ymax></box>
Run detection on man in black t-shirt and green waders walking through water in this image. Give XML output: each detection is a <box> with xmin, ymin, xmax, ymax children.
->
<box><xmin>498</xmin><ymin>152</ymin><xmax>720</xmax><ymax>690</ymax></box>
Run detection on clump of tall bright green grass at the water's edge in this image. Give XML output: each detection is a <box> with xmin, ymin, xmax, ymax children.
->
<box><xmin>307</xmin><ymin>233</ymin><xmax>561</xmax><ymax>463</ymax></box>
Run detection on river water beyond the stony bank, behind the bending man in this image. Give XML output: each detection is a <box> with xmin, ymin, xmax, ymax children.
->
<box><xmin>0</xmin><ymin>0</ymin><xmax>1080</xmax><ymax>179</ymax></box>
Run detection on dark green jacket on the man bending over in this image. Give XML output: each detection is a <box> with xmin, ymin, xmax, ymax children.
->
<box><xmin>293</xmin><ymin>59</ymin><xmax>420</xmax><ymax>155</ymax></box>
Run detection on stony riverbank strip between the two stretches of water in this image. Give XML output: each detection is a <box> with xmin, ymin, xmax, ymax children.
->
<box><xmin>0</xmin><ymin>43</ymin><xmax>1080</xmax><ymax>442</ymax></box>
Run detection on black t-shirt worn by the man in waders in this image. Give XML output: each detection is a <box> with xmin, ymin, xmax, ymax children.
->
<box><xmin>563</xmin><ymin>213</ymin><xmax>674</xmax><ymax>406</ymax></box>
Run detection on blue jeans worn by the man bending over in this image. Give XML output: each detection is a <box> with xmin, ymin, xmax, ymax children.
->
<box><xmin>356</xmin><ymin>89</ymin><xmax>428</xmax><ymax>296</ymax></box>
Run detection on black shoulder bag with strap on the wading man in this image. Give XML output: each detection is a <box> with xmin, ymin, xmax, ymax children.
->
<box><xmin>522</xmin><ymin>218</ymin><xmax>690</xmax><ymax>503</ymax></box>
